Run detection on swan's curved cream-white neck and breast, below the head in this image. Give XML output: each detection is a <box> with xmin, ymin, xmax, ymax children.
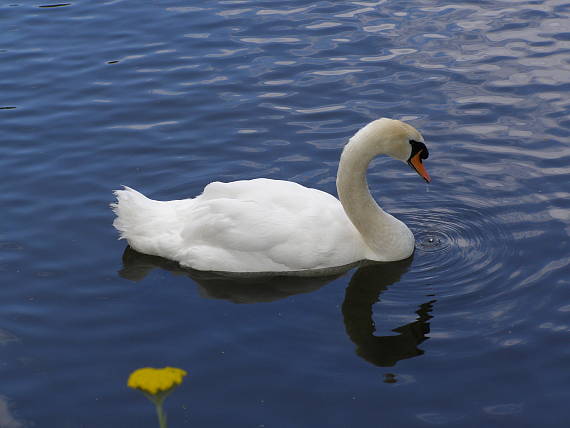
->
<box><xmin>336</xmin><ymin>129</ymin><xmax>414</xmax><ymax>261</ymax></box>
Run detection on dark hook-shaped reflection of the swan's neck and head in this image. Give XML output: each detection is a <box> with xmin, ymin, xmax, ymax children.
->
<box><xmin>342</xmin><ymin>259</ymin><xmax>435</xmax><ymax>367</ymax></box>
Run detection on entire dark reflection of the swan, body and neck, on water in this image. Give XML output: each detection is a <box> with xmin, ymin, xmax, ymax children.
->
<box><xmin>119</xmin><ymin>247</ymin><xmax>435</xmax><ymax>366</ymax></box>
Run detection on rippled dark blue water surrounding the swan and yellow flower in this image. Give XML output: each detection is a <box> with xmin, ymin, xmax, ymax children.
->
<box><xmin>0</xmin><ymin>0</ymin><xmax>570</xmax><ymax>428</ymax></box>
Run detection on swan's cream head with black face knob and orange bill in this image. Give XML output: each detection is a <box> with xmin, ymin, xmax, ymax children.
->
<box><xmin>353</xmin><ymin>118</ymin><xmax>431</xmax><ymax>183</ymax></box>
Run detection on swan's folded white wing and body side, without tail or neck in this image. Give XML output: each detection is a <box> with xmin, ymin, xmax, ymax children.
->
<box><xmin>175</xmin><ymin>179</ymin><xmax>363</xmax><ymax>271</ymax></box>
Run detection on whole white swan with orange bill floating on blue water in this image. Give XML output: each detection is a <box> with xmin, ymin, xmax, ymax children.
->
<box><xmin>111</xmin><ymin>118</ymin><xmax>430</xmax><ymax>274</ymax></box>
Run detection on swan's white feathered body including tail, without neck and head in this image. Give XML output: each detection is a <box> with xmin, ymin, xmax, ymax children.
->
<box><xmin>114</xmin><ymin>179</ymin><xmax>365</xmax><ymax>272</ymax></box>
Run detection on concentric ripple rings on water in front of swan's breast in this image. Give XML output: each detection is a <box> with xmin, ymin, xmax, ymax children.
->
<box><xmin>400</xmin><ymin>201</ymin><xmax>513</xmax><ymax>296</ymax></box>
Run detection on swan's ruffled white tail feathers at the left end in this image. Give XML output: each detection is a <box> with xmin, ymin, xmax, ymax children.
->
<box><xmin>111</xmin><ymin>186</ymin><xmax>171</xmax><ymax>254</ymax></box>
